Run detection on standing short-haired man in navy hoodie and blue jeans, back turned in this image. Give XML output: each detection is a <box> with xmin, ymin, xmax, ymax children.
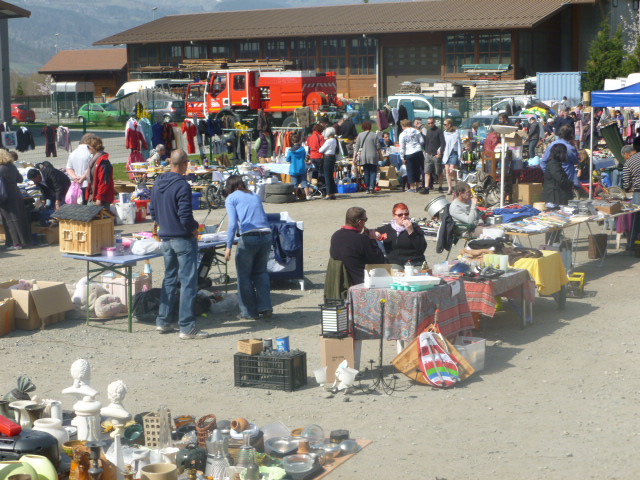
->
<box><xmin>149</xmin><ymin>150</ymin><xmax>209</xmax><ymax>340</ymax></box>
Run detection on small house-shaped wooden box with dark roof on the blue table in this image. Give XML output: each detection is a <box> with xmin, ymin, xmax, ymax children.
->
<box><xmin>54</xmin><ymin>205</ymin><xmax>115</xmax><ymax>255</ymax></box>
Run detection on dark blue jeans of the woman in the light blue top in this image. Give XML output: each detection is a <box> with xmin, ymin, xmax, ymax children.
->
<box><xmin>236</xmin><ymin>233</ymin><xmax>273</xmax><ymax>318</ymax></box>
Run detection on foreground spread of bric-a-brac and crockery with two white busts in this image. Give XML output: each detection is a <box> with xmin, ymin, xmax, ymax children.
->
<box><xmin>0</xmin><ymin>370</ymin><xmax>371</xmax><ymax>480</ymax></box>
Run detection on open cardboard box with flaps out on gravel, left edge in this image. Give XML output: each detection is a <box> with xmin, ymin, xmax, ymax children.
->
<box><xmin>0</xmin><ymin>280</ymin><xmax>74</xmax><ymax>330</ymax></box>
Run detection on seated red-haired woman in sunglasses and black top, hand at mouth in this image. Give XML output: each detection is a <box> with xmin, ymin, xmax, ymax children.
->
<box><xmin>376</xmin><ymin>203</ymin><xmax>427</xmax><ymax>267</ymax></box>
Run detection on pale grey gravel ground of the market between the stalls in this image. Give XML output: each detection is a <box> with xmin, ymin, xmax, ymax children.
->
<box><xmin>0</xmin><ymin>192</ymin><xmax>640</xmax><ymax>480</ymax></box>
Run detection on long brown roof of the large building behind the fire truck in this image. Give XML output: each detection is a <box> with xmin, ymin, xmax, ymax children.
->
<box><xmin>94</xmin><ymin>0</ymin><xmax>595</xmax><ymax>45</ymax></box>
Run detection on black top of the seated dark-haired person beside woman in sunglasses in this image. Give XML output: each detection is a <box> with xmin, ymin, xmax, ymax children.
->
<box><xmin>329</xmin><ymin>228</ymin><xmax>387</xmax><ymax>285</ymax></box>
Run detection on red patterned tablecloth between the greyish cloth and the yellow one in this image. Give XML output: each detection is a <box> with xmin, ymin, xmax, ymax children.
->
<box><xmin>464</xmin><ymin>270</ymin><xmax>536</xmax><ymax>317</ymax></box>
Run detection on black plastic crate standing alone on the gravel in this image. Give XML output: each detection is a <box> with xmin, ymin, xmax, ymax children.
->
<box><xmin>233</xmin><ymin>352</ymin><xmax>307</xmax><ymax>392</ymax></box>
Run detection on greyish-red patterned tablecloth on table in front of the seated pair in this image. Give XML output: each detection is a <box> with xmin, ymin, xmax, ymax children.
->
<box><xmin>347</xmin><ymin>280</ymin><xmax>474</xmax><ymax>340</ymax></box>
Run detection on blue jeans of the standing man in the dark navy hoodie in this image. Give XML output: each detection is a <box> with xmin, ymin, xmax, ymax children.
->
<box><xmin>156</xmin><ymin>237</ymin><xmax>198</xmax><ymax>333</ymax></box>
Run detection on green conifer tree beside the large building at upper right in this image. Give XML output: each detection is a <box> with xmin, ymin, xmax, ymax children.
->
<box><xmin>583</xmin><ymin>18</ymin><xmax>625</xmax><ymax>92</ymax></box>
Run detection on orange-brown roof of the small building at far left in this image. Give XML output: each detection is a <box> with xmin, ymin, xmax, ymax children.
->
<box><xmin>38</xmin><ymin>48</ymin><xmax>127</xmax><ymax>74</ymax></box>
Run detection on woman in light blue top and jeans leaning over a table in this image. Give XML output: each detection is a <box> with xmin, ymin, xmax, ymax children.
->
<box><xmin>224</xmin><ymin>175</ymin><xmax>273</xmax><ymax>320</ymax></box>
